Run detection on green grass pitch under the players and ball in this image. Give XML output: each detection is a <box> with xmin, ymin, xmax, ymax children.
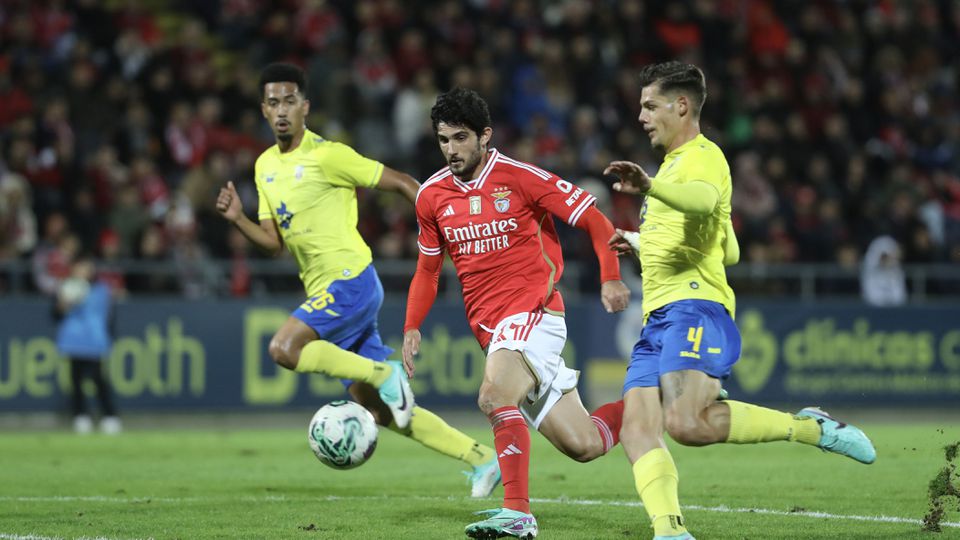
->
<box><xmin>0</xmin><ymin>420</ymin><xmax>960</xmax><ymax>540</ymax></box>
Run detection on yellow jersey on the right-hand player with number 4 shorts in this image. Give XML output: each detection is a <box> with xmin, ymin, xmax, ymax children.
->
<box><xmin>639</xmin><ymin>134</ymin><xmax>736</xmax><ymax>316</ymax></box>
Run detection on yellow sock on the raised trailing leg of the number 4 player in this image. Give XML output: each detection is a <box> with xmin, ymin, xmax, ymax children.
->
<box><xmin>724</xmin><ymin>400</ymin><xmax>820</xmax><ymax>445</ymax></box>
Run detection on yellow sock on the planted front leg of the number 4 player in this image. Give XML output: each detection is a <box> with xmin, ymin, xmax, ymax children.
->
<box><xmin>633</xmin><ymin>448</ymin><xmax>687</xmax><ymax>536</ymax></box>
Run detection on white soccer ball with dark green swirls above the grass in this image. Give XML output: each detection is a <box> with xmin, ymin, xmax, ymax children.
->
<box><xmin>307</xmin><ymin>400</ymin><xmax>377</xmax><ymax>469</ymax></box>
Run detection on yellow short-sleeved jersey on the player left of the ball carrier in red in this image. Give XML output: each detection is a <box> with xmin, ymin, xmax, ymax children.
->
<box><xmin>255</xmin><ymin>130</ymin><xmax>383</xmax><ymax>297</ymax></box>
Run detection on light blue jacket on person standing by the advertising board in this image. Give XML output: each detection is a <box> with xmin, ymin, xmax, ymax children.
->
<box><xmin>57</xmin><ymin>283</ymin><xmax>112</xmax><ymax>360</ymax></box>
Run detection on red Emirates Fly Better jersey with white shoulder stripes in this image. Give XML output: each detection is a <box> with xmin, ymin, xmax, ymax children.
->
<box><xmin>417</xmin><ymin>150</ymin><xmax>596</xmax><ymax>348</ymax></box>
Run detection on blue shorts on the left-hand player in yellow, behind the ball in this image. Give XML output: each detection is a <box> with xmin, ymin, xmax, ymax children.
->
<box><xmin>292</xmin><ymin>264</ymin><xmax>393</xmax><ymax>387</ymax></box>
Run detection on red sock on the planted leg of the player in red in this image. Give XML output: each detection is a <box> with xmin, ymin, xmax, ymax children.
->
<box><xmin>490</xmin><ymin>405</ymin><xmax>532</xmax><ymax>514</ymax></box>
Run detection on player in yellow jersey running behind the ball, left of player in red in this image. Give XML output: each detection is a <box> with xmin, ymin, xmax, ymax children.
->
<box><xmin>217</xmin><ymin>64</ymin><xmax>500</xmax><ymax>497</ymax></box>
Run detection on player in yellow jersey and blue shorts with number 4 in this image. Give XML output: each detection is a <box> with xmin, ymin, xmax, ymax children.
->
<box><xmin>604</xmin><ymin>62</ymin><xmax>876</xmax><ymax>539</ymax></box>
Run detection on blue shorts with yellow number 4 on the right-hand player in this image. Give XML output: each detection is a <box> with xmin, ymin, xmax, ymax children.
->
<box><xmin>623</xmin><ymin>300</ymin><xmax>740</xmax><ymax>393</ymax></box>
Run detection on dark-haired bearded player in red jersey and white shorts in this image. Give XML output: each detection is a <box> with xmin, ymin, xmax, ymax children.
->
<box><xmin>403</xmin><ymin>88</ymin><xmax>630</xmax><ymax>538</ymax></box>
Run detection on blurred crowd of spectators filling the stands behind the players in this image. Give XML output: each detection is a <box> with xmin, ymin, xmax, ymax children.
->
<box><xmin>0</xmin><ymin>0</ymin><xmax>960</xmax><ymax>295</ymax></box>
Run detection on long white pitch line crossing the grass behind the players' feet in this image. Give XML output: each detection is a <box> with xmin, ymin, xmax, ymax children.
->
<box><xmin>0</xmin><ymin>495</ymin><xmax>960</xmax><ymax>540</ymax></box>
